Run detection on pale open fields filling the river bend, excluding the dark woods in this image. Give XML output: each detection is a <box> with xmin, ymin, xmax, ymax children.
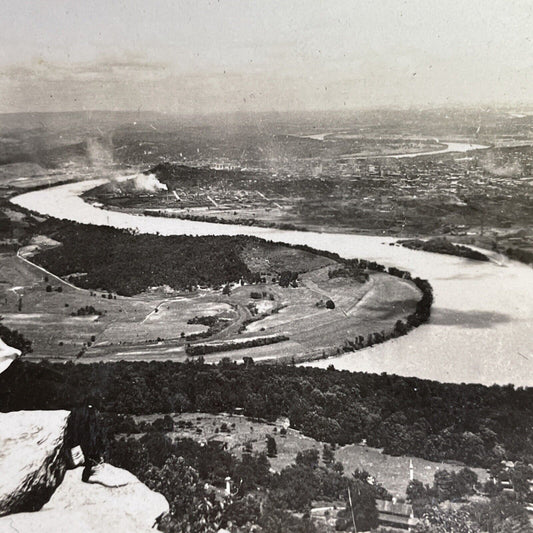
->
<box><xmin>0</xmin><ymin>238</ymin><xmax>420</xmax><ymax>362</ymax></box>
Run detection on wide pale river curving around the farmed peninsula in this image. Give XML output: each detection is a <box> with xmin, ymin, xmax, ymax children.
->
<box><xmin>12</xmin><ymin>179</ymin><xmax>533</xmax><ymax>386</ymax></box>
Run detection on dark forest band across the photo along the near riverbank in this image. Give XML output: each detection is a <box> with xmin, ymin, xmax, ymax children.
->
<box><xmin>0</xmin><ymin>360</ymin><xmax>533</xmax><ymax>467</ymax></box>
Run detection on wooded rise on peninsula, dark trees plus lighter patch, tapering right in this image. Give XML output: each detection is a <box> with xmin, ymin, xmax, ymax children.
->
<box><xmin>30</xmin><ymin>219</ymin><xmax>390</xmax><ymax>296</ymax></box>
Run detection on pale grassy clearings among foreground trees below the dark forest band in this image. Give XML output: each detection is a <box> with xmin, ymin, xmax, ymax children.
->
<box><xmin>130</xmin><ymin>413</ymin><xmax>488</xmax><ymax>497</ymax></box>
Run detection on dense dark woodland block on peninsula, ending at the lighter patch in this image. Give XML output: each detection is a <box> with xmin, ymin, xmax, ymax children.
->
<box><xmin>34</xmin><ymin>220</ymin><xmax>258</xmax><ymax>296</ymax></box>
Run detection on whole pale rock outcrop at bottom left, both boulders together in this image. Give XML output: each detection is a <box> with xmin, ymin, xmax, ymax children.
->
<box><xmin>0</xmin><ymin>410</ymin><xmax>169</xmax><ymax>533</ymax></box>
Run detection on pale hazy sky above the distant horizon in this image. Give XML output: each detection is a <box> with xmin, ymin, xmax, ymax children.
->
<box><xmin>0</xmin><ymin>0</ymin><xmax>533</xmax><ymax>112</ymax></box>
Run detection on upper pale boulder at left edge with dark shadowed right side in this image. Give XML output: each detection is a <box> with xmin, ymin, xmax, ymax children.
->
<box><xmin>0</xmin><ymin>411</ymin><xmax>70</xmax><ymax>516</ymax></box>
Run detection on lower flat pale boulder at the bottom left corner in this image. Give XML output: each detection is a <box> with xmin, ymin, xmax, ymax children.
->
<box><xmin>0</xmin><ymin>465</ymin><xmax>169</xmax><ymax>533</ymax></box>
